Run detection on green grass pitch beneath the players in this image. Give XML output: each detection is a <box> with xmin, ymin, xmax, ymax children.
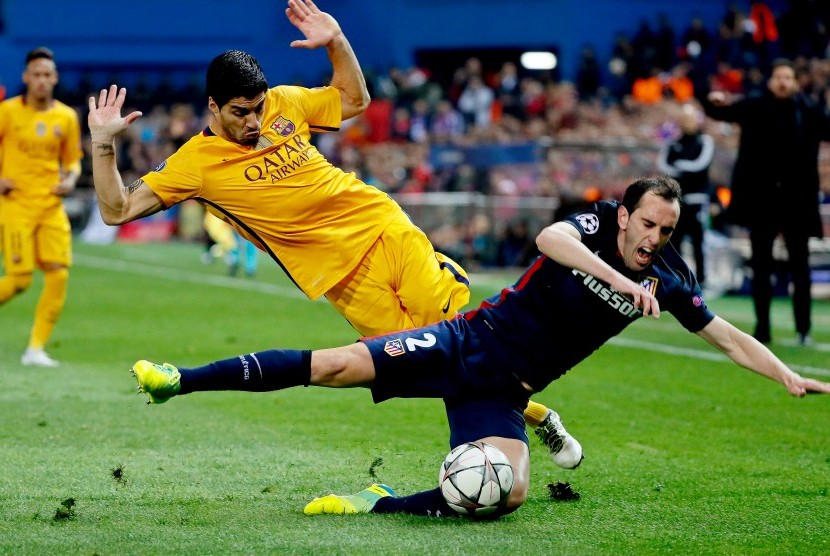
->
<box><xmin>0</xmin><ymin>243</ymin><xmax>830</xmax><ymax>555</ymax></box>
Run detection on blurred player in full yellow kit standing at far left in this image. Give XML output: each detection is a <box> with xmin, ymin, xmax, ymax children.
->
<box><xmin>0</xmin><ymin>47</ymin><xmax>83</xmax><ymax>367</ymax></box>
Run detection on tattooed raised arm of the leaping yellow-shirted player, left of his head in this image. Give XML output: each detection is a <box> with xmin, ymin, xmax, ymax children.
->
<box><xmin>88</xmin><ymin>85</ymin><xmax>164</xmax><ymax>225</ymax></box>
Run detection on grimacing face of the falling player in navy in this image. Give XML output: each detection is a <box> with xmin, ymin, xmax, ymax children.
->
<box><xmin>617</xmin><ymin>192</ymin><xmax>680</xmax><ymax>271</ymax></box>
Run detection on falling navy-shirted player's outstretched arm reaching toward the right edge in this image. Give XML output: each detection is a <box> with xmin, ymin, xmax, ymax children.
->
<box><xmin>697</xmin><ymin>317</ymin><xmax>830</xmax><ymax>397</ymax></box>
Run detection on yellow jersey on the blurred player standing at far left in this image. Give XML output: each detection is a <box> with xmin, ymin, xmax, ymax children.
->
<box><xmin>0</xmin><ymin>96</ymin><xmax>83</xmax><ymax>214</ymax></box>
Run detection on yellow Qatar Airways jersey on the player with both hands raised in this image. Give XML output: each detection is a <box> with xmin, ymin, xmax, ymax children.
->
<box><xmin>142</xmin><ymin>86</ymin><xmax>402</xmax><ymax>299</ymax></box>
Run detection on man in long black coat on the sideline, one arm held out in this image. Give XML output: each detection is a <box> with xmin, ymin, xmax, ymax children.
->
<box><xmin>703</xmin><ymin>59</ymin><xmax>830</xmax><ymax>344</ymax></box>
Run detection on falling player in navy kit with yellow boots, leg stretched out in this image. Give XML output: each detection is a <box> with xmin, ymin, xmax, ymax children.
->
<box><xmin>128</xmin><ymin>176</ymin><xmax>830</xmax><ymax>516</ymax></box>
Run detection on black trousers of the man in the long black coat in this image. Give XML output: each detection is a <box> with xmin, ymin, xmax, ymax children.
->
<box><xmin>749</xmin><ymin>222</ymin><xmax>812</xmax><ymax>338</ymax></box>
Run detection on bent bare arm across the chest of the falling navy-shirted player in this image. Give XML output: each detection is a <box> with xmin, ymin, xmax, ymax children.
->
<box><xmin>536</xmin><ymin>222</ymin><xmax>660</xmax><ymax>318</ymax></box>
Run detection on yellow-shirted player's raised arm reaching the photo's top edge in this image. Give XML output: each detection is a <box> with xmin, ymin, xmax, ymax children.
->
<box><xmin>285</xmin><ymin>0</ymin><xmax>369</xmax><ymax>120</ymax></box>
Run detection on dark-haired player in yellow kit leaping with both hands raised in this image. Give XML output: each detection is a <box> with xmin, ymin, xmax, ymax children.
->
<box><xmin>84</xmin><ymin>0</ymin><xmax>582</xmax><ymax>467</ymax></box>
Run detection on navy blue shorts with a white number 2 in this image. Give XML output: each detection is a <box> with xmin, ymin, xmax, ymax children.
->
<box><xmin>361</xmin><ymin>318</ymin><xmax>529</xmax><ymax>447</ymax></box>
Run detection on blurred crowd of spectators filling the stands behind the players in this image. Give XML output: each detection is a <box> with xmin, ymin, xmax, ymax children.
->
<box><xmin>63</xmin><ymin>0</ymin><xmax>830</xmax><ymax>267</ymax></box>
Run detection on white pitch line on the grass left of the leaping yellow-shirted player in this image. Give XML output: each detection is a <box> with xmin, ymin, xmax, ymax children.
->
<box><xmin>73</xmin><ymin>253</ymin><xmax>310</xmax><ymax>299</ymax></box>
